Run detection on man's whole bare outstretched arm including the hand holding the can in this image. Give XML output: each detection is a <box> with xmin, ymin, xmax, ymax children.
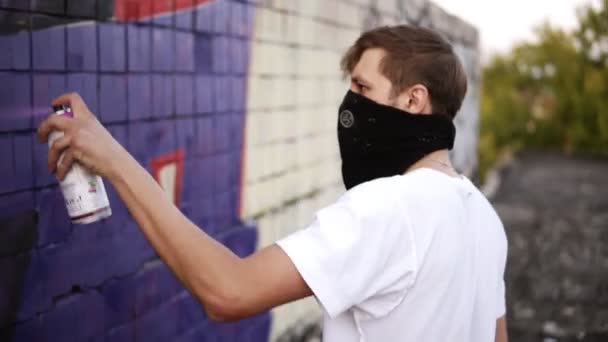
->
<box><xmin>38</xmin><ymin>93</ymin><xmax>312</xmax><ymax>321</ymax></box>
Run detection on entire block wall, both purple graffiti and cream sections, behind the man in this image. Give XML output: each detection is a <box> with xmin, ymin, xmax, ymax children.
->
<box><xmin>0</xmin><ymin>0</ymin><xmax>478</xmax><ymax>341</ymax></box>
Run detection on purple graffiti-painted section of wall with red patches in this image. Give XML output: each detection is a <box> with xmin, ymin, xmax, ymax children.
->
<box><xmin>0</xmin><ymin>0</ymin><xmax>270</xmax><ymax>341</ymax></box>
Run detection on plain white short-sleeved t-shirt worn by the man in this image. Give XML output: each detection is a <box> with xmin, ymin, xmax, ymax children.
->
<box><xmin>277</xmin><ymin>168</ymin><xmax>507</xmax><ymax>342</ymax></box>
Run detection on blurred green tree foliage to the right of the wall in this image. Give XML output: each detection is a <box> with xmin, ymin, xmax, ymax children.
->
<box><xmin>479</xmin><ymin>0</ymin><xmax>608</xmax><ymax>175</ymax></box>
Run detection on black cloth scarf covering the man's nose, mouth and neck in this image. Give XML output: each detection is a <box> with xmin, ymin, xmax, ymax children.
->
<box><xmin>338</xmin><ymin>91</ymin><xmax>456</xmax><ymax>189</ymax></box>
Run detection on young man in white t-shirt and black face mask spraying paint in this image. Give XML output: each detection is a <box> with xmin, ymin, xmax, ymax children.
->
<box><xmin>38</xmin><ymin>26</ymin><xmax>507</xmax><ymax>342</ymax></box>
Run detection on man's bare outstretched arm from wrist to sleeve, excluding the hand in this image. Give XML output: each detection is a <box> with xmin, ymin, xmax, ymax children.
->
<box><xmin>111</xmin><ymin>152</ymin><xmax>312</xmax><ymax>320</ymax></box>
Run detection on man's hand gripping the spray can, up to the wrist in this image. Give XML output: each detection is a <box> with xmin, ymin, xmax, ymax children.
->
<box><xmin>38</xmin><ymin>93</ymin><xmax>128</xmax><ymax>180</ymax></box>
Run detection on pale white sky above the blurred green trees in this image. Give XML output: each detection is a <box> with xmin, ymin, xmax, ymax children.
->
<box><xmin>432</xmin><ymin>0</ymin><xmax>597</xmax><ymax>59</ymax></box>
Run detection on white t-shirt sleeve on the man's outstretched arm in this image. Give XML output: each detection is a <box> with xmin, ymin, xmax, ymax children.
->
<box><xmin>277</xmin><ymin>180</ymin><xmax>417</xmax><ymax>318</ymax></box>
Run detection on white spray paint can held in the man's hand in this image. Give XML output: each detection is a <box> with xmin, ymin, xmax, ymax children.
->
<box><xmin>48</xmin><ymin>105</ymin><xmax>112</xmax><ymax>224</ymax></box>
